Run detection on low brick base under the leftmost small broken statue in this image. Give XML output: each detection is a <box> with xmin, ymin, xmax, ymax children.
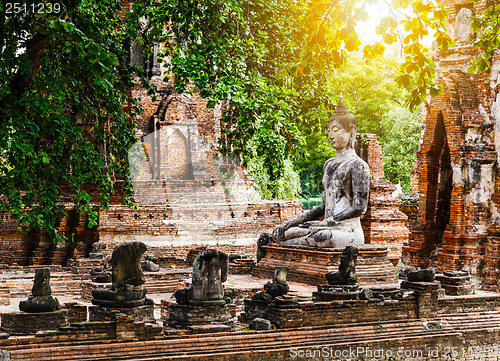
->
<box><xmin>0</xmin><ymin>309</ymin><xmax>69</xmax><ymax>335</ymax></box>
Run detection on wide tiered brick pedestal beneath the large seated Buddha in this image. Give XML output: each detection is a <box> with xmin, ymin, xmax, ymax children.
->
<box><xmin>252</xmin><ymin>244</ymin><xmax>398</xmax><ymax>285</ymax></box>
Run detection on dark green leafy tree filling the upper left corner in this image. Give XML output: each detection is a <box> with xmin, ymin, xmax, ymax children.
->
<box><xmin>0</xmin><ymin>0</ymin><xmax>146</xmax><ymax>240</ymax></box>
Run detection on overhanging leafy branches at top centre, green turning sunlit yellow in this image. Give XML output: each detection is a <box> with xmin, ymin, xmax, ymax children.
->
<box><xmin>137</xmin><ymin>0</ymin><xmax>451</xmax><ymax>194</ymax></box>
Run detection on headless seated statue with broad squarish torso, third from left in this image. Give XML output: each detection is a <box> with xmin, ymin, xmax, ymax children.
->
<box><xmin>174</xmin><ymin>249</ymin><xmax>229</xmax><ymax>306</ymax></box>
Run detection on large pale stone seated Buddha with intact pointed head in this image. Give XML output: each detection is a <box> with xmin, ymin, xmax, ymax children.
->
<box><xmin>273</xmin><ymin>97</ymin><xmax>370</xmax><ymax>248</ymax></box>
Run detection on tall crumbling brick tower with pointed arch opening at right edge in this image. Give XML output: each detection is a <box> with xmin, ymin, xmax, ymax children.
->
<box><xmin>404</xmin><ymin>0</ymin><xmax>500</xmax><ymax>290</ymax></box>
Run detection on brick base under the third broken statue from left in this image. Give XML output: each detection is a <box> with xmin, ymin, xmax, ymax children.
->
<box><xmin>161</xmin><ymin>300</ymin><xmax>235</xmax><ymax>328</ymax></box>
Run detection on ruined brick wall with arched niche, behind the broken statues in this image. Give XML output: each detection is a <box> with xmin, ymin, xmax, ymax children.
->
<box><xmin>0</xmin><ymin>81</ymin><xmax>302</xmax><ymax>265</ymax></box>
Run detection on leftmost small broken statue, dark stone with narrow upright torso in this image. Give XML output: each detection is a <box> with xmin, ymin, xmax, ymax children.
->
<box><xmin>19</xmin><ymin>268</ymin><xmax>61</xmax><ymax>313</ymax></box>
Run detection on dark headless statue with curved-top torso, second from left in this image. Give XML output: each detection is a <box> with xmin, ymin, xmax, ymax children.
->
<box><xmin>92</xmin><ymin>242</ymin><xmax>152</xmax><ymax>308</ymax></box>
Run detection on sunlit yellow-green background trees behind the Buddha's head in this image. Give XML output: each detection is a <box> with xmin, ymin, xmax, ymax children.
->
<box><xmin>295</xmin><ymin>57</ymin><xmax>422</xmax><ymax>195</ymax></box>
